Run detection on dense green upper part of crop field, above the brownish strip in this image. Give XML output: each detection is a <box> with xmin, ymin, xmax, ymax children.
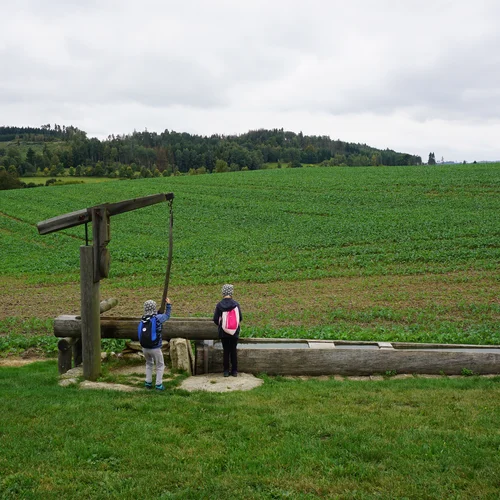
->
<box><xmin>0</xmin><ymin>166</ymin><xmax>500</xmax><ymax>284</ymax></box>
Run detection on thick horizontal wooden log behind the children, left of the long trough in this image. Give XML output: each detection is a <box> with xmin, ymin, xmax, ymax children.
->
<box><xmin>54</xmin><ymin>315</ymin><xmax>219</xmax><ymax>340</ymax></box>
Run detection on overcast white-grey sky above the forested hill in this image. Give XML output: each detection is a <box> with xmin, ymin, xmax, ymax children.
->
<box><xmin>0</xmin><ymin>0</ymin><xmax>500</xmax><ymax>161</ymax></box>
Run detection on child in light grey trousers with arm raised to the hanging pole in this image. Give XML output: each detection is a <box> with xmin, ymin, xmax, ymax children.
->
<box><xmin>139</xmin><ymin>298</ymin><xmax>172</xmax><ymax>391</ymax></box>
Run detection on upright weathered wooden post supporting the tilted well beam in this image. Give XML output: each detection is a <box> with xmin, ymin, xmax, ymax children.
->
<box><xmin>80</xmin><ymin>246</ymin><xmax>101</xmax><ymax>380</ymax></box>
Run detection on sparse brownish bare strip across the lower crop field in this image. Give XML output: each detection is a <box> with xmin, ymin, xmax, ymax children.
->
<box><xmin>0</xmin><ymin>271</ymin><xmax>500</xmax><ymax>327</ymax></box>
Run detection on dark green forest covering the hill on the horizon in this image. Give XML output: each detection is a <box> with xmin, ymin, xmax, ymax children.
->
<box><xmin>0</xmin><ymin>124</ymin><xmax>422</xmax><ymax>188</ymax></box>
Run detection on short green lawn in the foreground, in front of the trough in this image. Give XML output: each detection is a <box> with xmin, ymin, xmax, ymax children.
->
<box><xmin>0</xmin><ymin>362</ymin><xmax>500</xmax><ymax>500</ymax></box>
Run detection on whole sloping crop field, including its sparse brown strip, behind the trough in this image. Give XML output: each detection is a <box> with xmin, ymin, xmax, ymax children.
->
<box><xmin>0</xmin><ymin>164</ymin><xmax>500</xmax><ymax>343</ymax></box>
